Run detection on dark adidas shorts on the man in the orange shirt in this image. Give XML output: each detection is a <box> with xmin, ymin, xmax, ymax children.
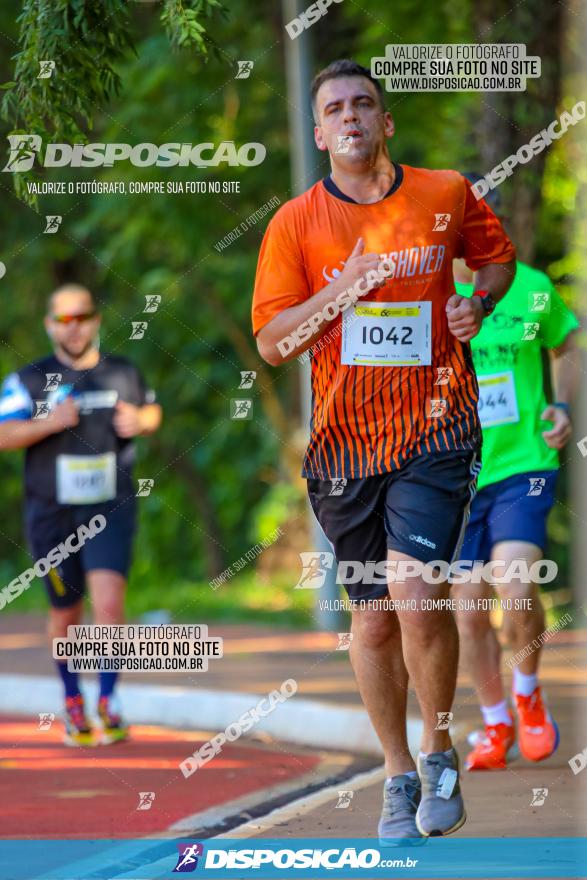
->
<box><xmin>308</xmin><ymin>452</ymin><xmax>481</xmax><ymax>601</ymax></box>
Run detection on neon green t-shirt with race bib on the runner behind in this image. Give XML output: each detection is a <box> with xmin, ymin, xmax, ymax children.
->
<box><xmin>455</xmin><ymin>262</ymin><xmax>579</xmax><ymax>489</ymax></box>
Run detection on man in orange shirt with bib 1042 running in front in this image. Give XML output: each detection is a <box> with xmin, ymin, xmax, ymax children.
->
<box><xmin>253</xmin><ymin>61</ymin><xmax>515</xmax><ymax>845</ymax></box>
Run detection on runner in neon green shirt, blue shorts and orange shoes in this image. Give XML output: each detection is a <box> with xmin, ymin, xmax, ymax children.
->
<box><xmin>453</xmin><ymin>175</ymin><xmax>580</xmax><ymax>770</ymax></box>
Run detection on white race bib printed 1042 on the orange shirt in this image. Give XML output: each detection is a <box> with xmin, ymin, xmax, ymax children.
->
<box><xmin>341</xmin><ymin>301</ymin><xmax>432</xmax><ymax>367</ymax></box>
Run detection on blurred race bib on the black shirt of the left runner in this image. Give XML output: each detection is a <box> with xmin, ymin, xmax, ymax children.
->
<box><xmin>56</xmin><ymin>452</ymin><xmax>116</xmax><ymax>504</ymax></box>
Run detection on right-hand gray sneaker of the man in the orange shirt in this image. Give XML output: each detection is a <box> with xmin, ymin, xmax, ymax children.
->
<box><xmin>416</xmin><ymin>749</ymin><xmax>467</xmax><ymax>837</ymax></box>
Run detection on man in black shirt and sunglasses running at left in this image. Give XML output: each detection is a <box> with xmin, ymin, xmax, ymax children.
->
<box><xmin>0</xmin><ymin>285</ymin><xmax>161</xmax><ymax>745</ymax></box>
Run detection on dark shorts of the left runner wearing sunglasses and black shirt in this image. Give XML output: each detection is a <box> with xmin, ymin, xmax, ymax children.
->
<box><xmin>25</xmin><ymin>495</ymin><xmax>136</xmax><ymax>608</ymax></box>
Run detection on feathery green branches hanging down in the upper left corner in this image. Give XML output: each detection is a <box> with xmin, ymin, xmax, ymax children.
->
<box><xmin>2</xmin><ymin>0</ymin><xmax>223</xmax><ymax>206</ymax></box>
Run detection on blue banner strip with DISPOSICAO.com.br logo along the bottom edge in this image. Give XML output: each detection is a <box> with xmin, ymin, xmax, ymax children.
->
<box><xmin>0</xmin><ymin>837</ymin><xmax>587</xmax><ymax>880</ymax></box>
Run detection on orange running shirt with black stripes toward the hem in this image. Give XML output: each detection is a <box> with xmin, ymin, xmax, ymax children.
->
<box><xmin>252</xmin><ymin>164</ymin><xmax>515</xmax><ymax>480</ymax></box>
